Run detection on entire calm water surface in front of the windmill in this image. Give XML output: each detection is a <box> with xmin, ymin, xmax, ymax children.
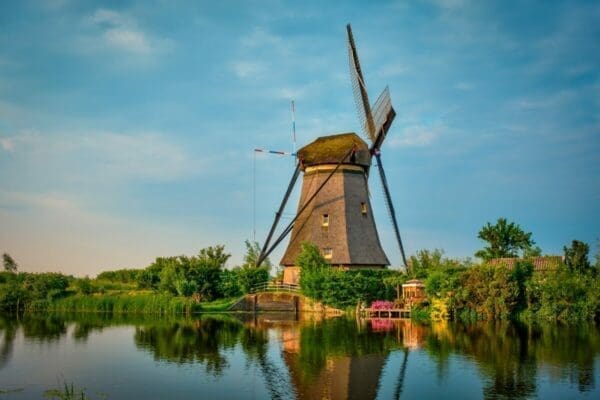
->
<box><xmin>0</xmin><ymin>314</ymin><xmax>600</xmax><ymax>399</ymax></box>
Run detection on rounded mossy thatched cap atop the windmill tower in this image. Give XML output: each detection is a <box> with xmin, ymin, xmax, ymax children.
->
<box><xmin>298</xmin><ymin>132</ymin><xmax>371</xmax><ymax>168</ymax></box>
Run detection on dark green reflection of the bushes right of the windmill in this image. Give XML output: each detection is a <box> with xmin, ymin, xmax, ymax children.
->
<box><xmin>426</xmin><ymin>321</ymin><xmax>600</xmax><ymax>399</ymax></box>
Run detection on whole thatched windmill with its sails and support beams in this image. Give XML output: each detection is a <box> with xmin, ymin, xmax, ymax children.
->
<box><xmin>257</xmin><ymin>24</ymin><xmax>406</xmax><ymax>283</ymax></box>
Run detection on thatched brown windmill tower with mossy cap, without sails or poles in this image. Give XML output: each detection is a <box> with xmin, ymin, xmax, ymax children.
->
<box><xmin>280</xmin><ymin>133</ymin><xmax>389</xmax><ymax>284</ymax></box>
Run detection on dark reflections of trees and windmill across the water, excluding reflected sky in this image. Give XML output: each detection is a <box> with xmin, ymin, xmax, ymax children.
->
<box><xmin>0</xmin><ymin>314</ymin><xmax>600</xmax><ymax>399</ymax></box>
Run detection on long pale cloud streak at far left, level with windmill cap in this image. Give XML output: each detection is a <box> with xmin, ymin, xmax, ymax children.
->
<box><xmin>2</xmin><ymin>132</ymin><xmax>203</xmax><ymax>181</ymax></box>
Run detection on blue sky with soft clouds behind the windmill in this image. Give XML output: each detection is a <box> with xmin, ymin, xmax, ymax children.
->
<box><xmin>0</xmin><ymin>0</ymin><xmax>600</xmax><ymax>275</ymax></box>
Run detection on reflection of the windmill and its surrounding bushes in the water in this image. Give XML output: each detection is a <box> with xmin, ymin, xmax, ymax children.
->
<box><xmin>281</xmin><ymin>319</ymin><xmax>426</xmax><ymax>399</ymax></box>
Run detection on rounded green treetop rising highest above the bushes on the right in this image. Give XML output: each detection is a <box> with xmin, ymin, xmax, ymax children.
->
<box><xmin>475</xmin><ymin>218</ymin><xmax>535</xmax><ymax>261</ymax></box>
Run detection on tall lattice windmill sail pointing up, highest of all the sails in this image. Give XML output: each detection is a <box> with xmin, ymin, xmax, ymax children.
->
<box><xmin>346</xmin><ymin>24</ymin><xmax>376</xmax><ymax>143</ymax></box>
